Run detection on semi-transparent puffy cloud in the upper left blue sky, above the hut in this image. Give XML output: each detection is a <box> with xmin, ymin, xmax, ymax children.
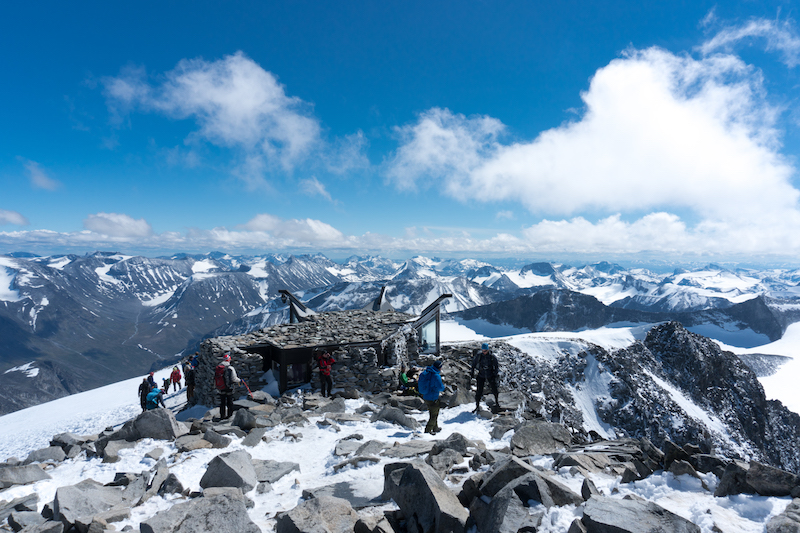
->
<box><xmin>103</xmin><ymin>52</ymin><xmax>366</xmax><ymax>188</ymax></box>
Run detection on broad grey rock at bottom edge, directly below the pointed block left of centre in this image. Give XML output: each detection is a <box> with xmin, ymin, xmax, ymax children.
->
<box><xmin>139</xmin><ymin>493</ymin><xmax>261</xmax><ymax>533</ymax></box>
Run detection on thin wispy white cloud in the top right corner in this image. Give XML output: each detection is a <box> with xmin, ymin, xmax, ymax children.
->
<box><xmin>699</xmin><ymin>17</ymin><xmax>800</xmax><ymax>67</ymax></box>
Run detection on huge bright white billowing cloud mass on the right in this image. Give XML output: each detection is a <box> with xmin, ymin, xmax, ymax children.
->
<box><xmin>387</xmin><ymin>30</ymin><xmax>800</xmax><ymax>253</ymax></box>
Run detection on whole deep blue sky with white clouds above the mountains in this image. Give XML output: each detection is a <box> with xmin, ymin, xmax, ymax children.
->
<box><xmin>0</xmin><ymin>1</ymin><xmax>800</xmax><ymax>262</ymax></box>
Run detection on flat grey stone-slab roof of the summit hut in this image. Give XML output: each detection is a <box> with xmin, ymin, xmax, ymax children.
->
<box><xmin>244</xmin><ymin>309</ymin><xmax>416</xmax><ymax>349</ymax></box>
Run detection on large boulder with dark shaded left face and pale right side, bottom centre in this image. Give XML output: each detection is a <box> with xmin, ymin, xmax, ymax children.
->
<box><xmin>383</xmin><ymin>461</ymin><xmax>469</xmax><ymax>533</ymax></box>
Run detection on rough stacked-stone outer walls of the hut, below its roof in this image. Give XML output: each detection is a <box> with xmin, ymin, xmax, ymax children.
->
<box><xmin>195</xmin><ymin>320</ymin><xmax>416</xmax><ymax>406</ymax></box>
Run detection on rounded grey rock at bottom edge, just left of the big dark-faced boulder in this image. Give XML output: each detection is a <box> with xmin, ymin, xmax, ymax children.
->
<box><xmin>275</xmin><ymin>495</ymin><xmax>358</xmax><ymax>533</ymax></box>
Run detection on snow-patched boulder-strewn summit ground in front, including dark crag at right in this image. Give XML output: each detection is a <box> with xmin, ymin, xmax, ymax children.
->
<box><xmin>0</xmin><ymin>323</ymin><xmax>800</xmax><ymax>533</ymax></box>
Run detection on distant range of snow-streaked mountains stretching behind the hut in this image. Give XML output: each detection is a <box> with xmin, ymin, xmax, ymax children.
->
<box><xmin>0</xmin><ymin>252</ymin><xmax>800</xmax><ymax>413</ymax></box>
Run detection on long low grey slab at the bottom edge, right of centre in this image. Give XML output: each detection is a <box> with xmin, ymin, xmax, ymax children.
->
<box><xmin>581</xmin><ymin>496</ymin><xmax>700</xmax><ymax>533</ymax></box>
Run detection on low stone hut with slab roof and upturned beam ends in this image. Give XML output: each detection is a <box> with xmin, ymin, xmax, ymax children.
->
<box><xmin>195</xmin><ymin>291</ymin><xmax>450</xmax><ymax>405</ymax></box>
